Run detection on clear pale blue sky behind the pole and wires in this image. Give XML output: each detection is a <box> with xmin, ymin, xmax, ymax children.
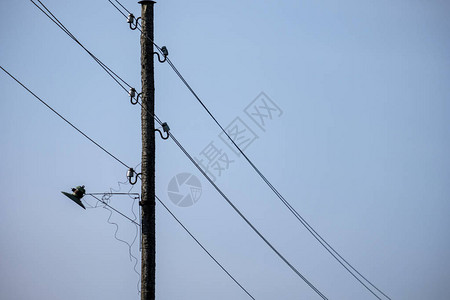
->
<box><xmin>0</xmin><ymin>0</ymin><xmax>450</xmax><ymax>300</ymax></box>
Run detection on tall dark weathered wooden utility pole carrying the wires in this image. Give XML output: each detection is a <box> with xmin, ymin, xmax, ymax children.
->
<box><xmin>139</xmin><ymin>1</ymin><xmax>156</xmax><ymax>300</ymax></box>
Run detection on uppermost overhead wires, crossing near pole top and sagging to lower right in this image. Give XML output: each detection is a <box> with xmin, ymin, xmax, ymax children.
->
<box><xmin>104</xmin><ymin>0</ymin><xmax>391</xmax><ymax>300</ymax></box>
